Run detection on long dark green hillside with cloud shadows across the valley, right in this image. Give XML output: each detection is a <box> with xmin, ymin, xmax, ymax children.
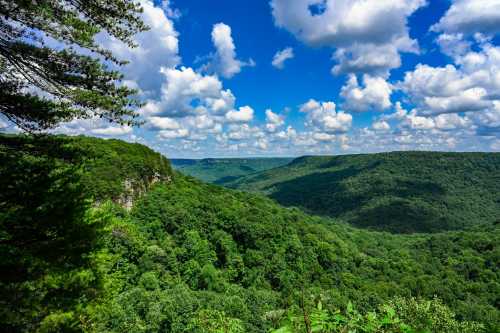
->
<box><xmin>225</xmin><ymin>152</ymin><xmax>500</xmax><ymax>233</ymax></box>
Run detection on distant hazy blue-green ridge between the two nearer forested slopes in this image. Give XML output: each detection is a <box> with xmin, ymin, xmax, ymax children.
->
<box><xmin>171</xmin><ymin>157</ymin><xmax>293</xmax><ymax>185</ymax></box>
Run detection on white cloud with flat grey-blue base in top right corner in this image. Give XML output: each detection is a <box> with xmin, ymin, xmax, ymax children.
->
<box><xmin>432</xmin><ymin>0</ymin><xmax>500</xmax><ymax>34</ymax></box>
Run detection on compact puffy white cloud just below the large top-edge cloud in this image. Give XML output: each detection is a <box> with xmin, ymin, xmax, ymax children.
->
<box><xmin>340</xmin><ymin>74</ymin><xmax>392</xmax><ymax>112</ymax></box>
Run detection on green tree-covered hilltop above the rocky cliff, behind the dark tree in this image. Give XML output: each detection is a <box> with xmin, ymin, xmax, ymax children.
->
<box><xmin>0</xmin><ymin>135</ymin><xmax>173</xmax><ymax>201</ymax></box>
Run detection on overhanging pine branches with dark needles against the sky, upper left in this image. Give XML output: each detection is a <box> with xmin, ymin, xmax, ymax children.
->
<box><xmin>0</xmin><ymin>0</ymin><xmax>146</xmax><ymax>131</ymax></box>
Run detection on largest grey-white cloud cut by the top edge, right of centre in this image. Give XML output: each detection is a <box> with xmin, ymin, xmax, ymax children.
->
<box><xmin>271</xmin><ymin>0</ymin><xmax>426</xmax><ymax>74</ymax></box>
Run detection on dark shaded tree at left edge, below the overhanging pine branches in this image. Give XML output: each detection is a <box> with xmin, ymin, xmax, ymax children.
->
<box><xmin>0</xmin><ymin>134</ymin><xmax>98</xmax><ymax>332</ymax></box>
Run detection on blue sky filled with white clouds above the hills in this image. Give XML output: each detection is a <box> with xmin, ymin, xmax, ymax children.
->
<box><xmin>0</xmin><ymin>0</ymin><xmax>500</xmax><ymax>158</ymax></box>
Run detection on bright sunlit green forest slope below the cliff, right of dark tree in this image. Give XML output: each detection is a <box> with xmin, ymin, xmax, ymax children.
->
<box><xmin>83</xmin><ymin>176</ymin><xmax>500</xmax><ymax>332</ymax></box>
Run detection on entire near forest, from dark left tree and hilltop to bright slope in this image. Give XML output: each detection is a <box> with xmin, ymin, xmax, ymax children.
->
<box><xmin>0</xmin><ymin>136</ymin><xmax>500</xmax><ymax>332</ymax></box>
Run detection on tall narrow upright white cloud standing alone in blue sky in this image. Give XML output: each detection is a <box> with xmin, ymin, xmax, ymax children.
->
<box><xmin>207</xmin><ymin>23</ymin><xmax>255</xmax><ymax>78</ymax></box>
